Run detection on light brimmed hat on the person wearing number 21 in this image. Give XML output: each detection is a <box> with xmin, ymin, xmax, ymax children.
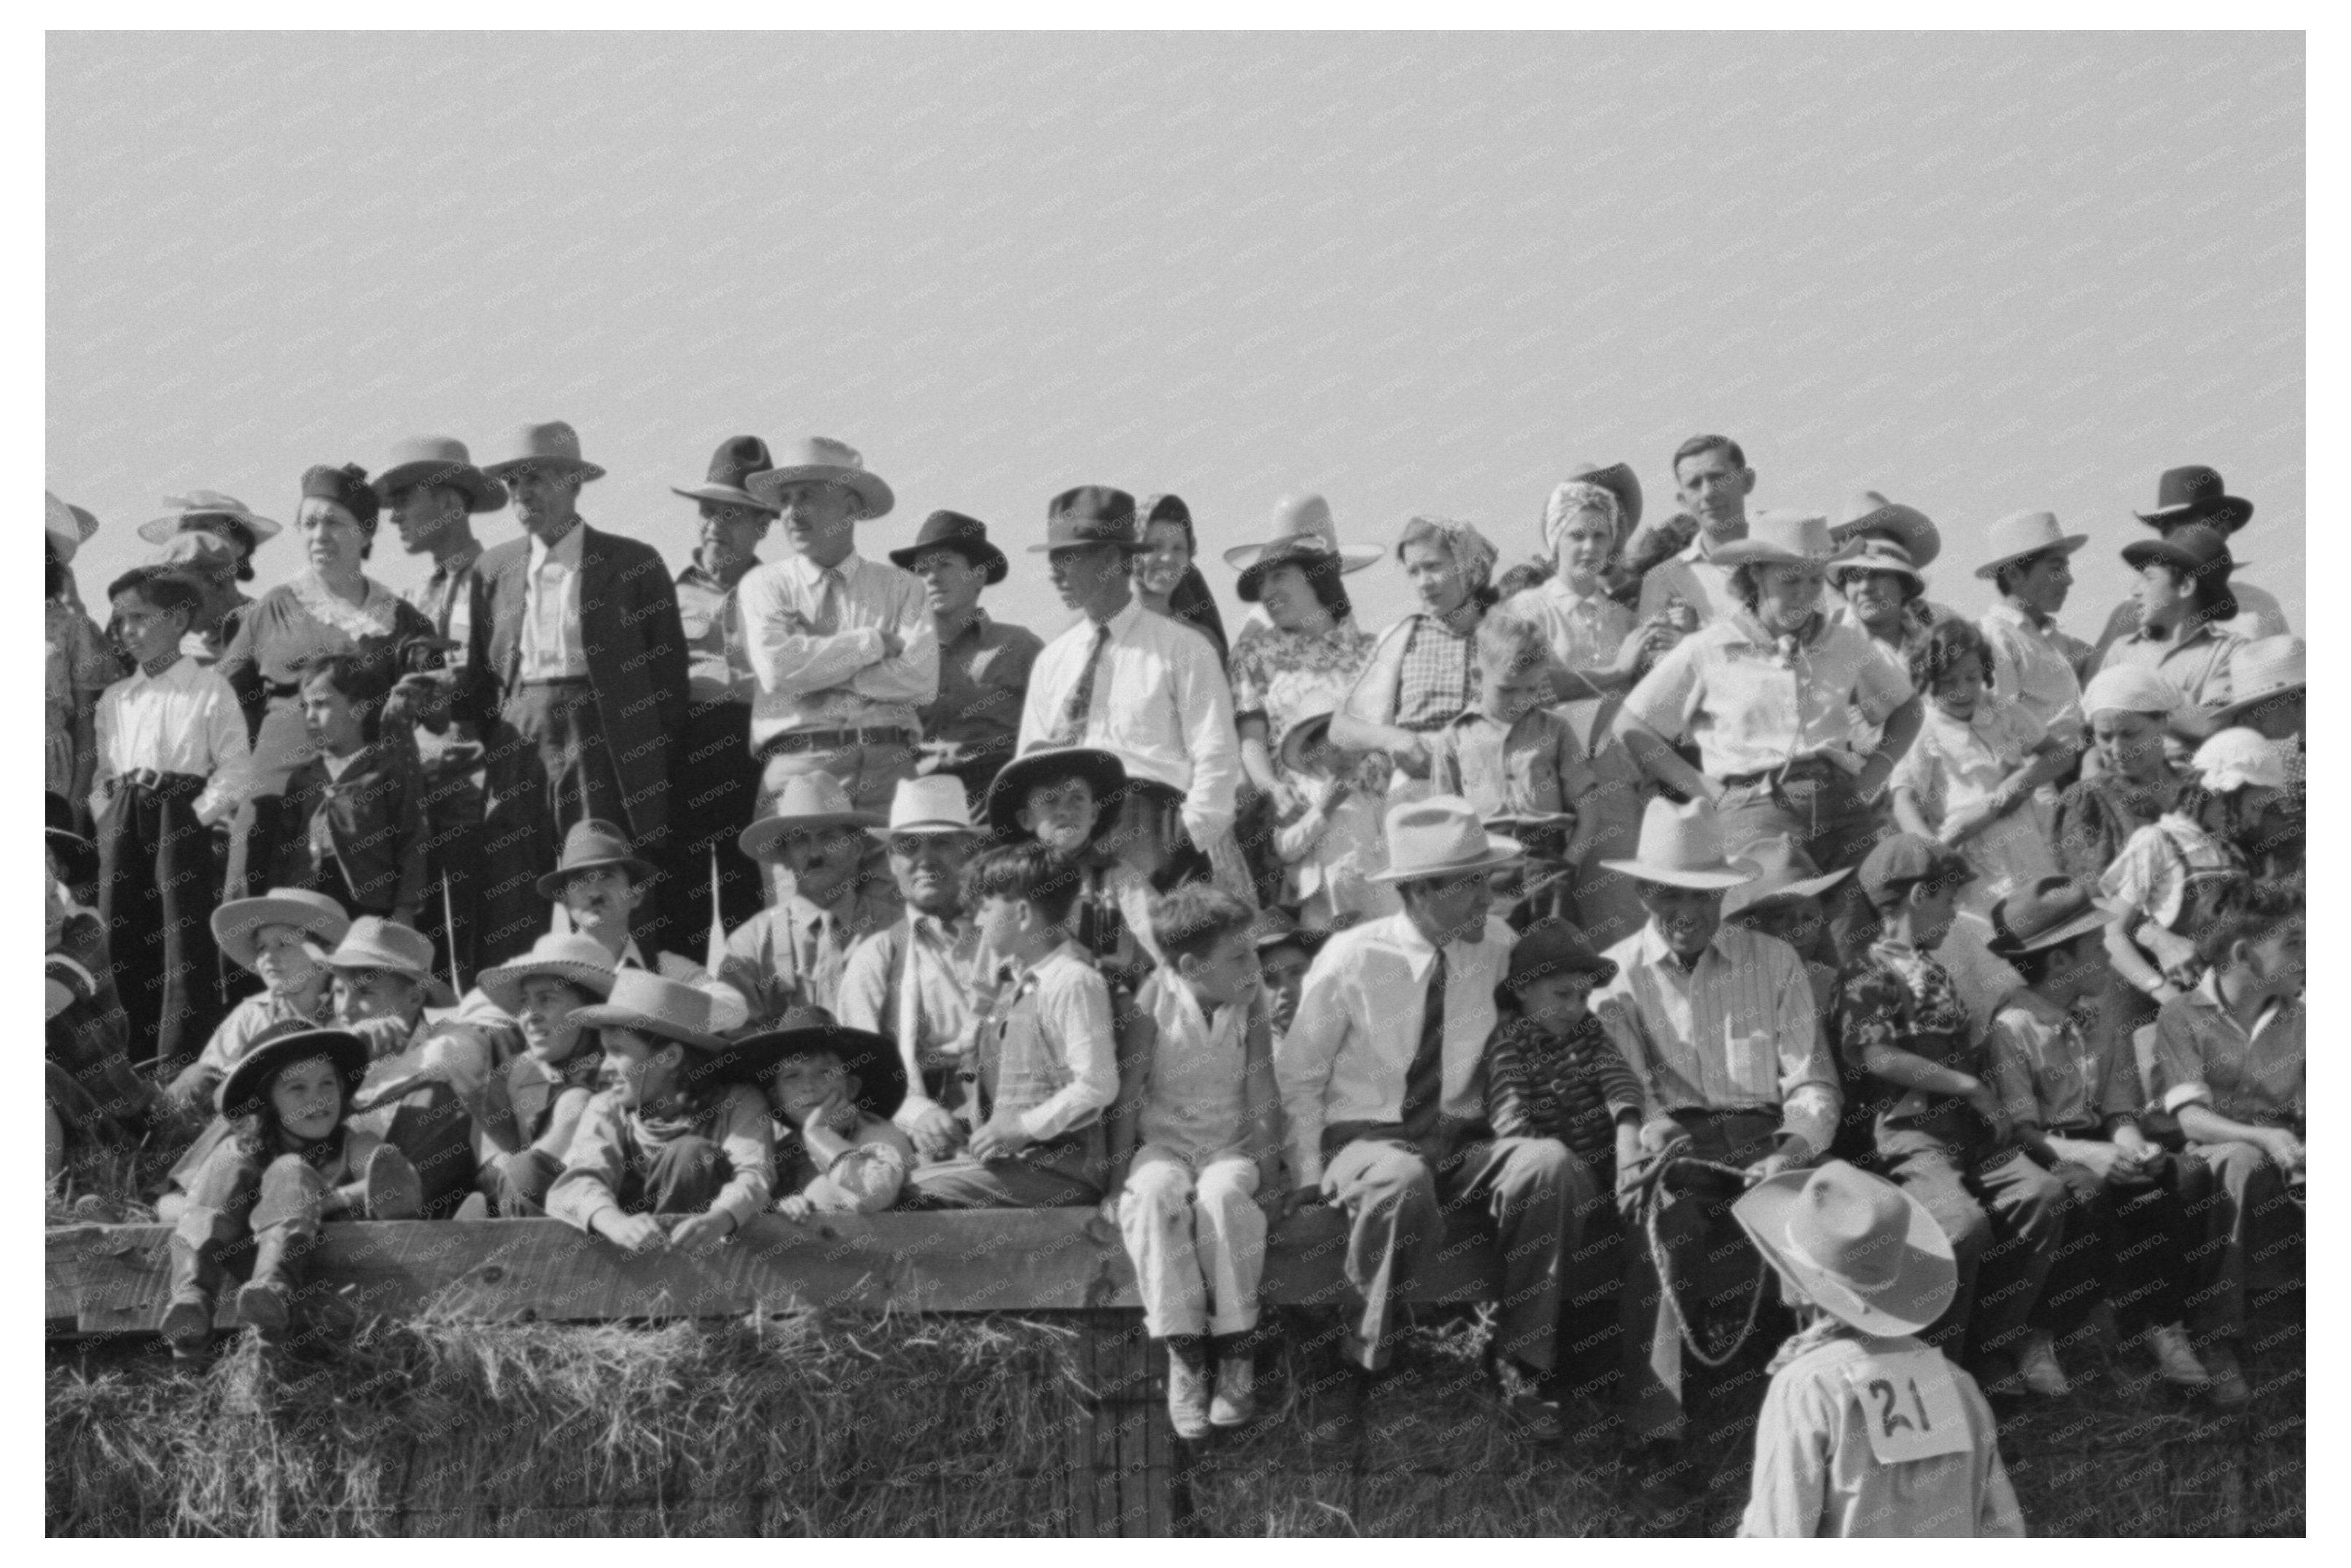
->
<box><xmin>1731</xmin><ymin>1159</ymin><xmax>1958</xmax><ymax>1338</ymax></box>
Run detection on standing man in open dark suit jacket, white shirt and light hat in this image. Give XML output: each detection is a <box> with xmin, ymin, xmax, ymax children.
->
<box><xmin>475</xmin><ymin>423</ymin><xmax>687</xmax><ymax>959</ymax></box>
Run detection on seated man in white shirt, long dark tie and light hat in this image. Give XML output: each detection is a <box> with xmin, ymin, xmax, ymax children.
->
<box><xmin>1274</xmin><ymin>795</ymin><xmax>1596</xmax><ymax>1436</ymax></box>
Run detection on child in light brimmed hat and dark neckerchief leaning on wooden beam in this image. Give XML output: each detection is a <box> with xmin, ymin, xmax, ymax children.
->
<box><xmin>547</xmin><ymin>969</ymin><xmax>776</xmax><ymax>1253</ymax></box>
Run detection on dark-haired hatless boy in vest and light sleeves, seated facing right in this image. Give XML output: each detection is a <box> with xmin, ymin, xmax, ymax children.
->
<box><xmin>910</xmin><ymin>844</ymin><xmax>1119</xmax><ymax>1209</ymax></box>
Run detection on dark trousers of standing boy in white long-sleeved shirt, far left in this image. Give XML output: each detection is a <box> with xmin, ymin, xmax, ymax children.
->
<box><xmin>98</xmin><ymin>773</ymin><xmax>226</xmax><ymax>1063</ymax></box>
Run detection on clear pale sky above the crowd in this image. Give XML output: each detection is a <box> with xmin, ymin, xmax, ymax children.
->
<box><xmin>47</xmin><ymin>33</ymin><xmax>2304</xmax><ymax>635</ymax></box>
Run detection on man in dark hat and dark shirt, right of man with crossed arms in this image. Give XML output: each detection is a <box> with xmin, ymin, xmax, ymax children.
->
<box><xmin>889</xmin><ymin>512</ymin><xmax>1044</xmax><ymax>799</ymax></box>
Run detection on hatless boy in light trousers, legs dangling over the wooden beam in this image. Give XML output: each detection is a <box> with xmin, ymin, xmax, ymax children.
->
<box><xmin>1110</xmin><ymin>884</ymin><xmax>1282</xmax><ymax>1441</ymax></box>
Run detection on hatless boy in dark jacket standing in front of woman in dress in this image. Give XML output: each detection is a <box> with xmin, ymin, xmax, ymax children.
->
<box><xmin>278</xmin><ymin>654</ymin><xmax>426</xmax><ymax>927</ymax></box>
